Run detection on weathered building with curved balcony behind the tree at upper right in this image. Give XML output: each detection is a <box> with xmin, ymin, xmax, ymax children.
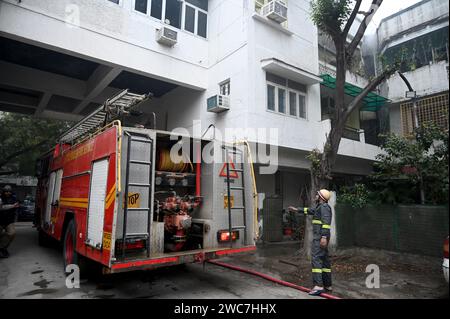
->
<box><xmin>370</xmin><ymin>0</ymin><xmax>449</xmax><ymax>134</ymax></box>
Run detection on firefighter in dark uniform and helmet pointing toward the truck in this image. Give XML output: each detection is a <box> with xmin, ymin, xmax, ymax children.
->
<box><xmin>289</xmin><ymin>189</ymin><xmax>332</xmax><ymax>296</ymax></box>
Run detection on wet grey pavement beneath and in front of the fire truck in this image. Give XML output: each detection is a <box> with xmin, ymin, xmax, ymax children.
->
<box><xmin>0</xmin><ymin>223</ymin><xmax>312</xmax><ymax>299</ymax></box>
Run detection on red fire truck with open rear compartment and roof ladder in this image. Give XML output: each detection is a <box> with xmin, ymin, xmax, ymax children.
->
<box><xmin>36</xmin><ymin>90</ymin><xmax>257</xmax><ymax>274</ymax></box>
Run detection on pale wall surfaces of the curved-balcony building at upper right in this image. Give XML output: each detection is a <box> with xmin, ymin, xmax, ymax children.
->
<box><xmin>372</xmin><ymin>0</ymin><xmax>449</xmax><ymax>134</ymax></box>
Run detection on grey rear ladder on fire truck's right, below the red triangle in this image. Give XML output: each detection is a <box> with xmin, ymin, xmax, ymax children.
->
<box><xmin>223</xmin><ymin>145</ymin><xmax>247</xmax><ymax>247</ymax></box>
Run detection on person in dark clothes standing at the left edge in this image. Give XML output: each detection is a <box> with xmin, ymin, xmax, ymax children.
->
<box><xmin>0</xmin><ymin>185</ymin><xmax>19</xmax><ymax>258</ymax></box>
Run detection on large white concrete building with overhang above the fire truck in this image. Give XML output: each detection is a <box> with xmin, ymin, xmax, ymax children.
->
<box><xmin>0</xmin><ymin>0</ymin><xmax>386</xmax><ymax>225</ymax></box>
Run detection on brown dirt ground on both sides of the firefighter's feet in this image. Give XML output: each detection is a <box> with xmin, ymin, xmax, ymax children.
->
<box><xmin>228</xmin><ymin>242</ymin><xmax>449</xmax><ymax>299</ymax></box>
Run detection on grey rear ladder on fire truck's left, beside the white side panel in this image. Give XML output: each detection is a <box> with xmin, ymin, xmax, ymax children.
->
<box><xmin>122</xmin><ymin>132</ymin><xmax>153</xmax><ymax>258</ymax></box>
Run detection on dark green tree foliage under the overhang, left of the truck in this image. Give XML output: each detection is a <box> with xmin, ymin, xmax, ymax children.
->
<box><xmin>0</xmin><ymin>112</ymin><xmax>70</xmax><ymax>175</ymax></box>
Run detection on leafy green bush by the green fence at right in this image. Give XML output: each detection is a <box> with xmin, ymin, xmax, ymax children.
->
<box><xmin>371</xmin><ymin>123</ymin><xmax>448</xmax><ymax>204</ymax></box>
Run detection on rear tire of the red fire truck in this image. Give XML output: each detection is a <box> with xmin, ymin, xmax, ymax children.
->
<box><xmin>63</xmin><ymin>219</ymin><xmax>88</xmax><ymax>278</ymax></box>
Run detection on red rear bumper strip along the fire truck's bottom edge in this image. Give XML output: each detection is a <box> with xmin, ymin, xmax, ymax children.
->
<box><xmin>103</xmin><ymin>246</ymin><xmax>256</xmax><ymax>274</ymax></box>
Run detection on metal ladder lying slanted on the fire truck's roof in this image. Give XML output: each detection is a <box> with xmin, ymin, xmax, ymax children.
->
<box><xmin>59</xmin><ymin>89</ymin><xmax>150</xmax><ymax>144</ymax></box>
